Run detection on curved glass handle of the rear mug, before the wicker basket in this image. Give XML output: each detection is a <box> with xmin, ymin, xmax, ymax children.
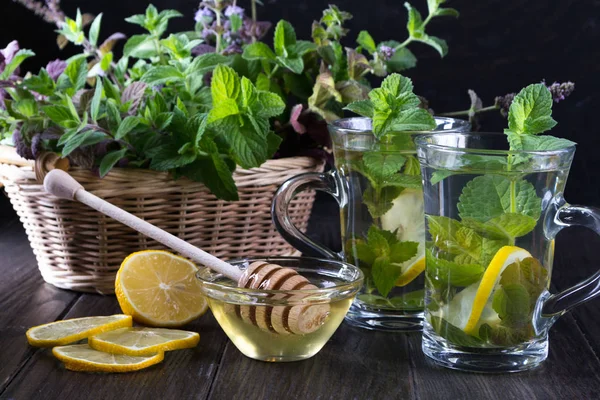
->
<box><xmin>271</xmin><ymin>171</ymin><xmax>345</xmax><ymax>261</ymax></box>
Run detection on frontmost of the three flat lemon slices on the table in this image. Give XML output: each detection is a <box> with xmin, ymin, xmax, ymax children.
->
<box><xmin>52</xmin><ymin>344</ymin><xmax>165</xmax><ymax>372</ymax></box>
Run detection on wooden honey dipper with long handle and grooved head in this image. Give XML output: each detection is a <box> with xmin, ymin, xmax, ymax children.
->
<box><xmin>44</xmin><ymin>169</ymin><xmax>330</xmax><ymax>335</ymax></box>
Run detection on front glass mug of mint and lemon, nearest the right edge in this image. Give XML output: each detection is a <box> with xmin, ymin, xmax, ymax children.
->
<box><xmin>417</xmin><ymin>133</ymin><xmax>600</xmax><ymax>372</ymax></box>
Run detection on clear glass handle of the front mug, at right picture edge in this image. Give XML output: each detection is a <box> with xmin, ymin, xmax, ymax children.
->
<box><xmin>541</xmin><ymin>203</ymin><xmax>600</xmax><ymax>319</ymax></box>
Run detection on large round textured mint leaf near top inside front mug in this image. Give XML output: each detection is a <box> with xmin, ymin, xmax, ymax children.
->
<box><xmin>457</xmin><ymin>175</ymin><xmax>542</xmax><ymax>222</ymax></box>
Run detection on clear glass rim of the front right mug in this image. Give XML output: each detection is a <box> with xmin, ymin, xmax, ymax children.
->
<box><xmin>415</xmin><ymin>132</ymin><xmax>576</xmax><ymax>157</ymax></box>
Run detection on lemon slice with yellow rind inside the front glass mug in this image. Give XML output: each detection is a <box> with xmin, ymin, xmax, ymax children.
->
<box><xmin>442</xmin><ymin>246</ymin><xmax>531</xmax><ymax>335</ymax></box>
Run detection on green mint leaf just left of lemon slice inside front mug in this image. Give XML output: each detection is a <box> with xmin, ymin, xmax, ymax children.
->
<box><xmin>425</xmin><ymin>249</ymin><xmax>485</xmax><ymax>287</ymax></box>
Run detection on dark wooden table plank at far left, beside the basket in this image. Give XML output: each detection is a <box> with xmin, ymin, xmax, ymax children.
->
<box><xmin>0</xmin><ymin>211</ymin><xmax>79</xmax><ymax>393</ymax></box>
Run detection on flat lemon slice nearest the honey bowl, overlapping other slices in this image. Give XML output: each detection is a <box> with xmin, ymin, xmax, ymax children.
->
<box><xmin>88</xmin><ymin>328</ymin><xmax>200</xmax><ymax>356</ymax></box>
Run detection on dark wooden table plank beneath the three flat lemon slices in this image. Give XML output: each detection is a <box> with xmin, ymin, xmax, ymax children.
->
<box><xmin>0</xmin><ymin>294</ymin><xmax>226</xmax><ymax>400</ymax></box>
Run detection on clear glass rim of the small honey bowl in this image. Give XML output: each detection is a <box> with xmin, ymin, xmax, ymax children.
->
<box><xmin>196</xmin><ymin>256</ymin><xmax>364</xmax><ymax>296</ymax></box>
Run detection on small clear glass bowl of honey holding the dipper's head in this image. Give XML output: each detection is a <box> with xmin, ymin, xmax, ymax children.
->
<box><xmin>197</xmin><ymin>257</ymin><xmax>364</xmax><ymax>362</ymax></box>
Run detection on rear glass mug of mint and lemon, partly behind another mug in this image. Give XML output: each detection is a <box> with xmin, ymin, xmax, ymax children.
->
<box><xmin>273</xmin><ymin>118</ymin><xmax>470</xmax><ymax>331</ymax></box>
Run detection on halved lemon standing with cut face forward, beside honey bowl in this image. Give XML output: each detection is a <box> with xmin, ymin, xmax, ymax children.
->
<box><xmin>115</xmin><ymin>250</ymin><xmax>208</xmax><ymax>327</ymax></box>
